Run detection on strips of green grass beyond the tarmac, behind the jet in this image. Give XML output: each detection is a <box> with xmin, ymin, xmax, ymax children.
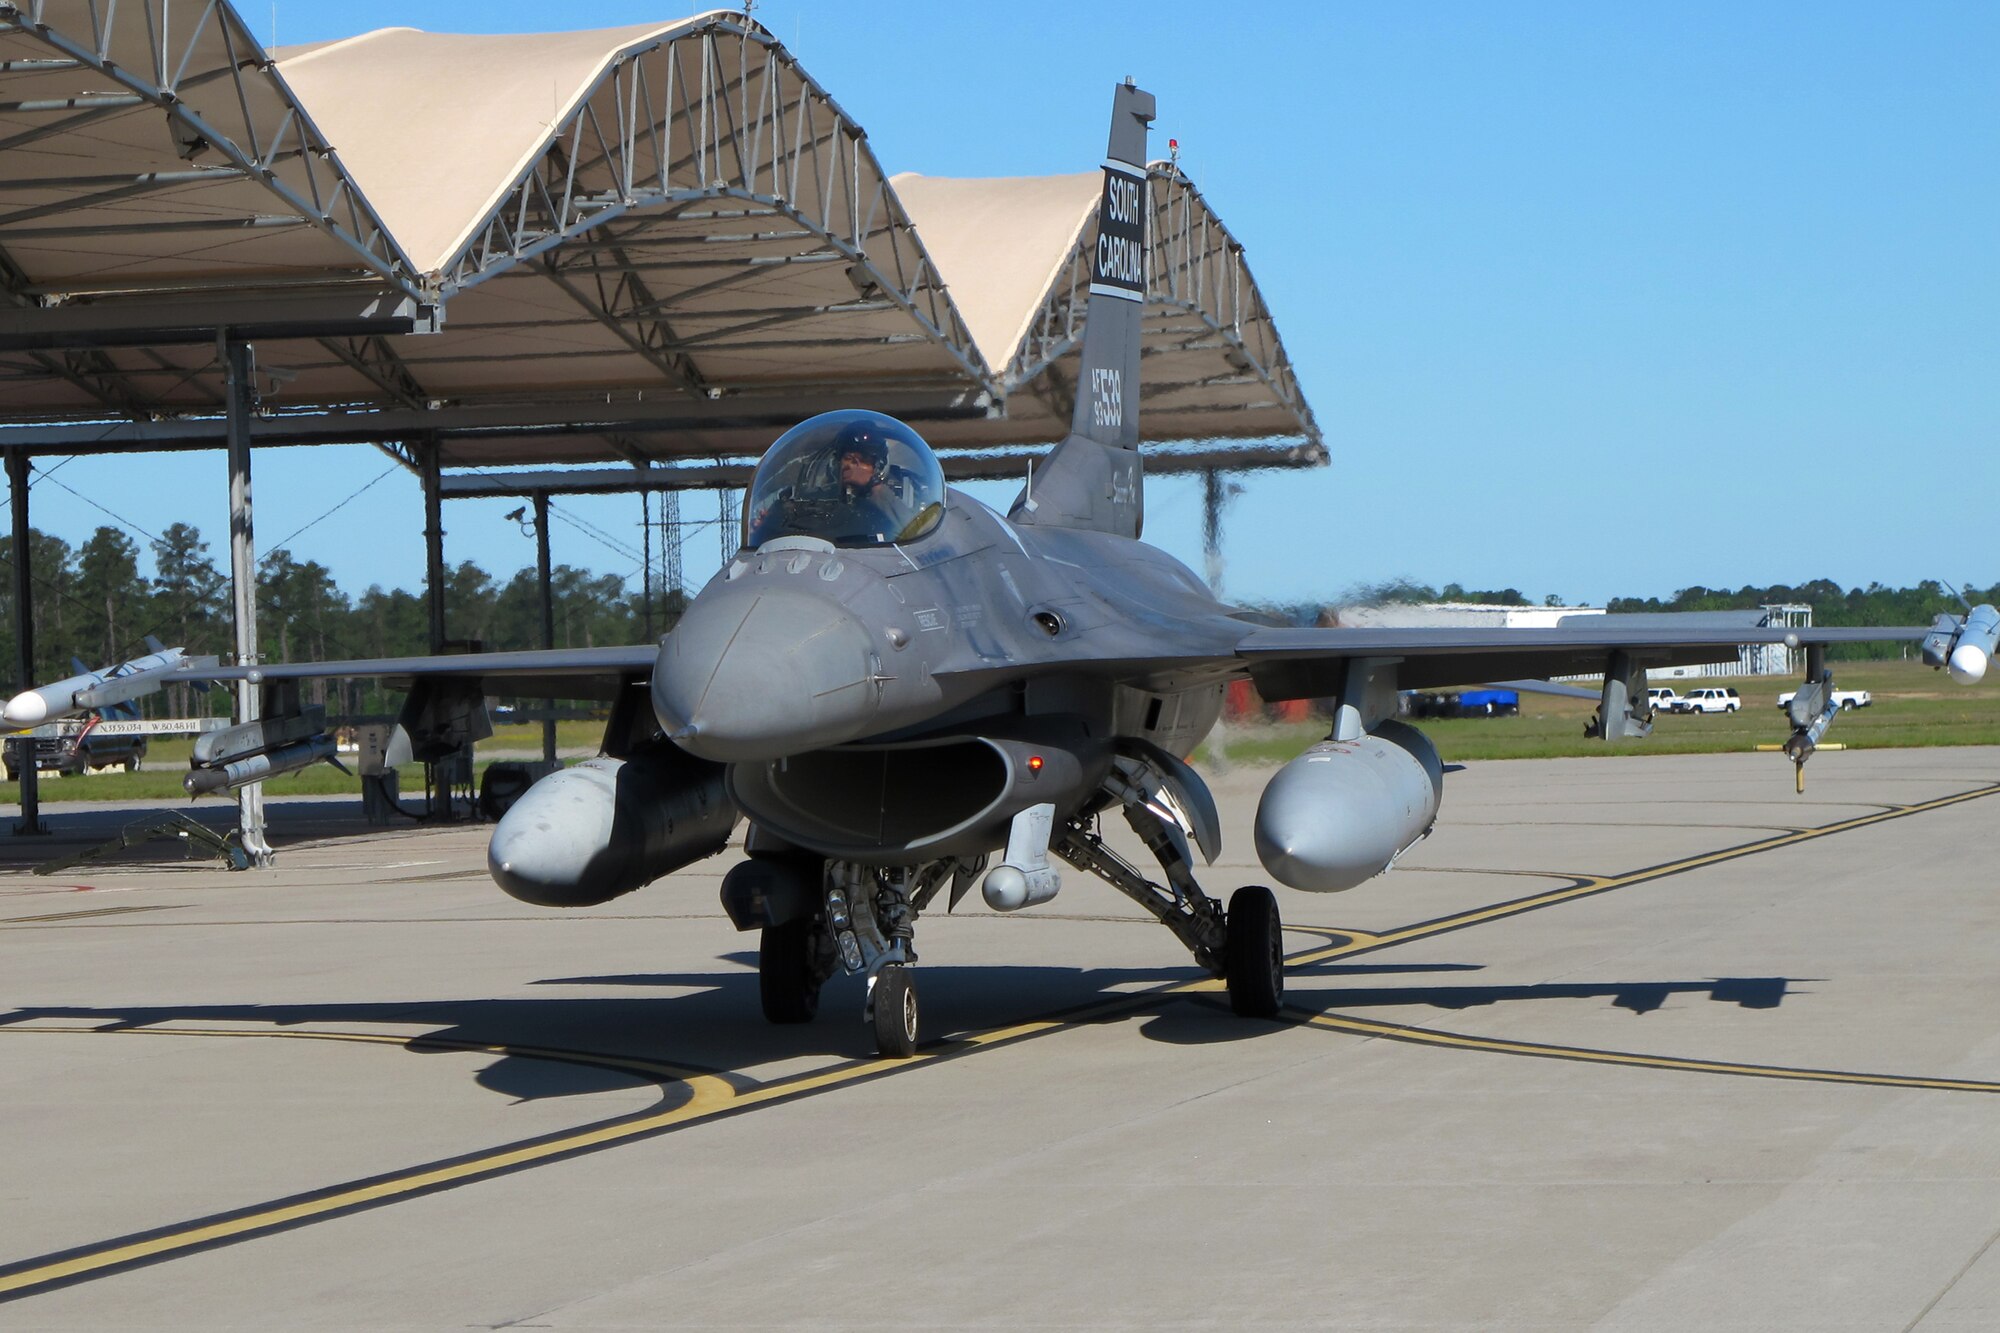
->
<box><xmin>19</xmin><ymin>662</ymin><xmax>2000</xmax><ymax>803</ymax></box>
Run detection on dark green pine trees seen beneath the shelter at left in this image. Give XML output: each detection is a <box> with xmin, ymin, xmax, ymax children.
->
<box><xmin>0</xmin><ymin>522</ymin><xmax>684</xmax><ymax>717</ymax></box>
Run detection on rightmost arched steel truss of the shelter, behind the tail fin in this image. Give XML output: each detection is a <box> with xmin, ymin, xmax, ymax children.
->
<box><xmin>1000</xmin><ymin>162</ymin><xmax>1324</xmax><ymax>446</ymax></box>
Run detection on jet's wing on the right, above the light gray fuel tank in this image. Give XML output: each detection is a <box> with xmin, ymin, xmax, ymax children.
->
<box><xmin>1236</xmin><ymin>610</ymin><xmax>1930</xmax><ymax>699</ymax></box>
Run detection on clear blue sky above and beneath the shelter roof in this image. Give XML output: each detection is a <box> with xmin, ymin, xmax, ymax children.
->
<box><xmin>19</xmin><ymin>0</ymin><xmax>2000</xmax><ymax>602</ymax></box>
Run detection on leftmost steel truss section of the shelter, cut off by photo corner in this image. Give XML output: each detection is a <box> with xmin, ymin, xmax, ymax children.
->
<box><xmin>0</xmin><ymin>0</ymin><xmax>422</xmax><ymax>302</ymax></box>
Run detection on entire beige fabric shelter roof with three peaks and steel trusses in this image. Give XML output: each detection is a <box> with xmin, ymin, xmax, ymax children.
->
<box><xmin>0</xmin><ymin>0</ymin><xmax>1324</xmax><ymax>464</ymax></box>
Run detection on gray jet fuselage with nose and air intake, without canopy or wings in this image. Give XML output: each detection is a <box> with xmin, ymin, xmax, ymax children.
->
<box><xmin>652</xmin><ymin>490</ymin><xmax>1246</xmax><ymax>861</ymax></box>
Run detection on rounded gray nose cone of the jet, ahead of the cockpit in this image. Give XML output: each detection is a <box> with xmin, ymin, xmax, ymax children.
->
<box><xmin>652</xmin><ymin>584</ymin><xmax>882</xmax><ymax>763</ymax></box>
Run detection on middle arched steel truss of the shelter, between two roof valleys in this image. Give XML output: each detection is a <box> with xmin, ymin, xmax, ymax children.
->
<box><xmin>434</xmin><ymin>16</ymin><xmax>992</xmax><ymax>392</ymax></box>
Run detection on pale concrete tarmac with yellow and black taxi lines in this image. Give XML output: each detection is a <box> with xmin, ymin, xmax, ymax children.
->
<box><xmin>0</xmin><ymin>749</ymin><xmax>2000</xmax><ymax>1331</ymax></box>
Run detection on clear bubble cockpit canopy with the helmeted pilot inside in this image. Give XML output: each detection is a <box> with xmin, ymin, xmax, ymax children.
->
<box><xmin>744</xmin><ymin>408</ymin><xmax>944</xmax><ymax>548</ymax></box>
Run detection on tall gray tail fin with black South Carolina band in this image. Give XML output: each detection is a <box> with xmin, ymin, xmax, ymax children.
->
<box><xmin>1008</xmin><ymin>84</ymin><xmax>1154</xmax><ymax>536</ymax></box>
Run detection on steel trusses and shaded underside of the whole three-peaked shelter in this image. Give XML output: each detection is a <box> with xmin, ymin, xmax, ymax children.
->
<box><xmin>0</xmin><ymin>0</ymin><xmax>1326</xmax><ymax>470</ymax></box>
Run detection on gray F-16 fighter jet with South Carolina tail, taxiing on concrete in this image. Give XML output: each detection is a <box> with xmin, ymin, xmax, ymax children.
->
<box><xmin>19</xmin><ymin>84</ymin><xmax>2000</xmax><ymax>1055</ymax></box>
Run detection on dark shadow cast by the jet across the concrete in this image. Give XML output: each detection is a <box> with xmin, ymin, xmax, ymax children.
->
<box><xmin>0</xmin><ymin>955</ymin><xmax>1792</xmax><ymax>1101</ymax></box>
